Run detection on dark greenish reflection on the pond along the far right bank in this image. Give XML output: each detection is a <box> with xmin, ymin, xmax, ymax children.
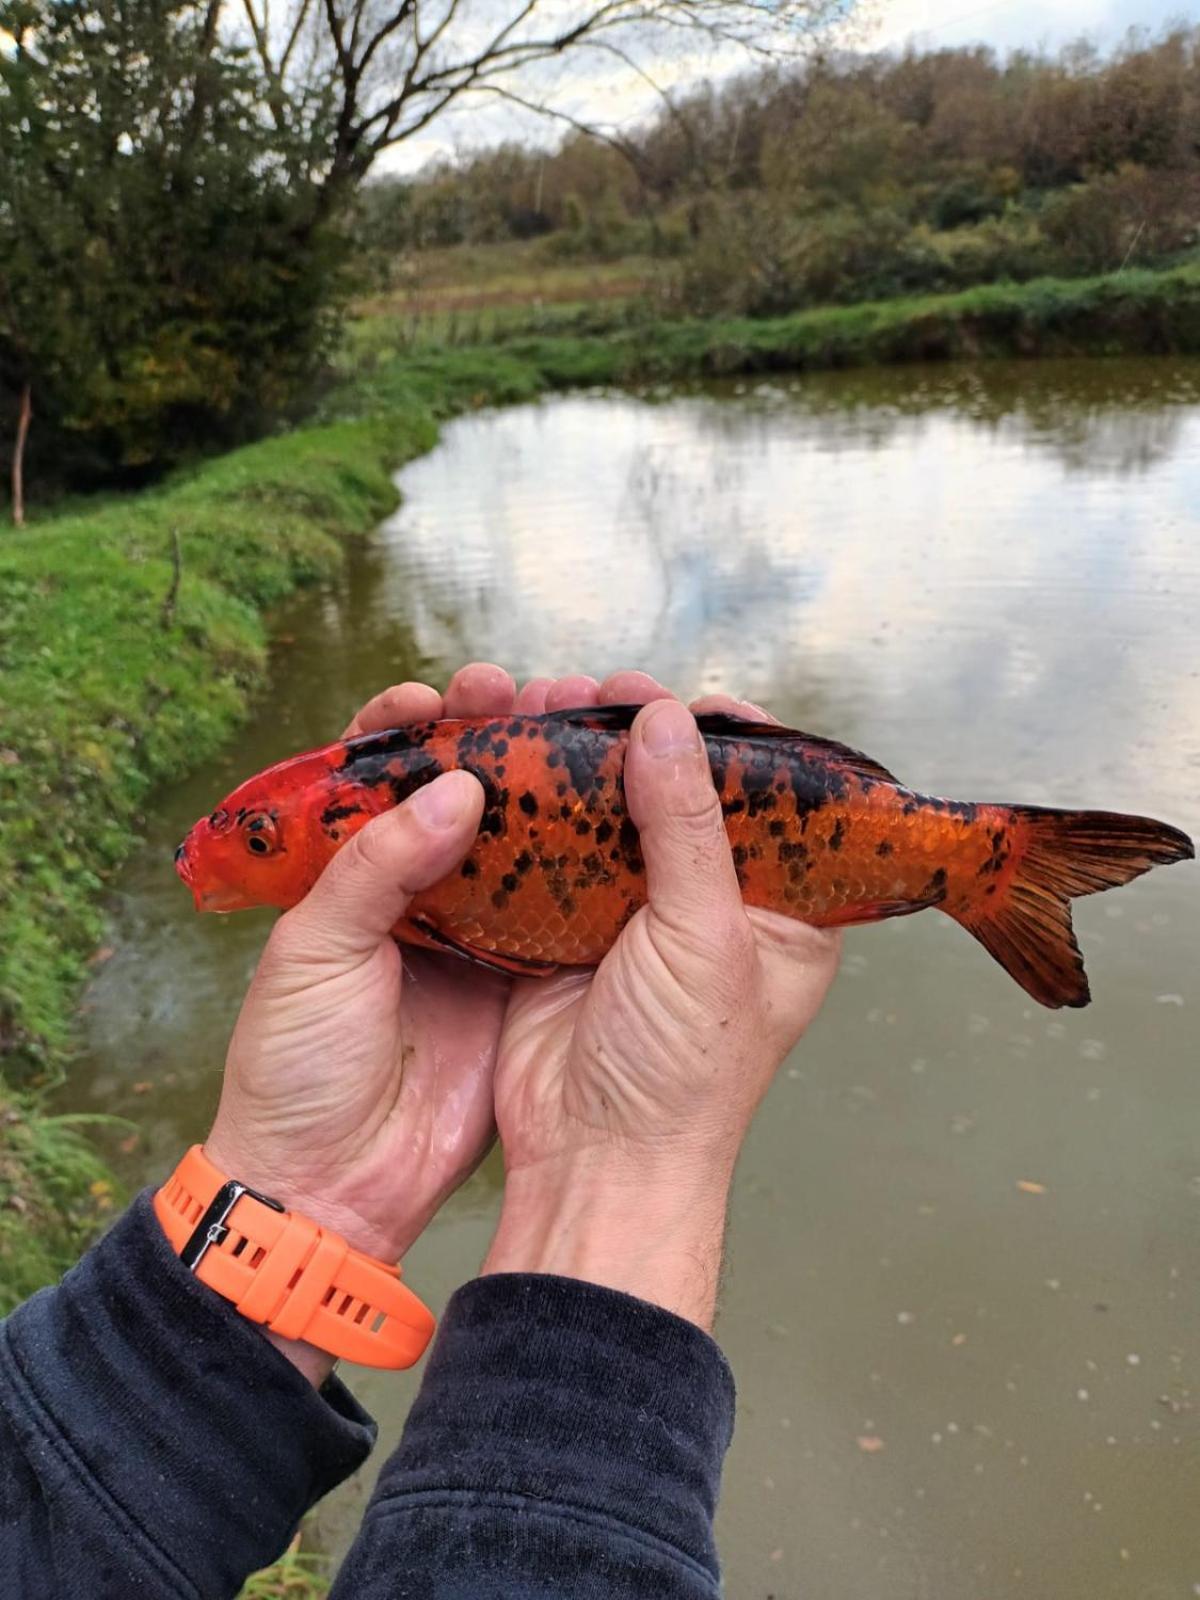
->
<box><xmin>681</xmin><ymin>360</ymin><xmax>1200</xmax><ymax>477</ymax></box>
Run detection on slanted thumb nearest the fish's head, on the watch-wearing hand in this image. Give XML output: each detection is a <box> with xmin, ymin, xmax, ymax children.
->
<box><xmin>288</xmin><ymin>771</ymin><xmax>483</xmax><ymax>960</ymax></box>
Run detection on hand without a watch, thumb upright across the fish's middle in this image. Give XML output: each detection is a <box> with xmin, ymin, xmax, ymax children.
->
<box><xmin>483</xmin><ymin>674</ymin><xmax>840</xmax><ymax>1326</ymax></box>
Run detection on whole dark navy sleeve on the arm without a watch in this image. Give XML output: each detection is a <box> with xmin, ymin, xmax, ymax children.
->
<box><xmin>333</xmin><ymin>1274</ymin><xmax>734</xmax><ymax>1600</ymax></box>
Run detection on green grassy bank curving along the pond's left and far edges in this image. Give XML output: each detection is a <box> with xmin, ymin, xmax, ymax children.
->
<box><xmin>0</xmin><ymin>267</ymin><xmax>1200</xmax><ymax>1286</ymax></box>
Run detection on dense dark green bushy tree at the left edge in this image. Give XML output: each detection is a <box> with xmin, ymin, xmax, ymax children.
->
<box><xmin>0</xmin><ymin>0</ymin><xmax>333</xmax><ymax>512</ymax></box>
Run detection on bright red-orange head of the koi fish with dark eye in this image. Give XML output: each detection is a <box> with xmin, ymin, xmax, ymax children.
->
<box><xmin>174</xmin><ymin>757</ymin><xmax>326</xmax><ymax>912</ymax></box>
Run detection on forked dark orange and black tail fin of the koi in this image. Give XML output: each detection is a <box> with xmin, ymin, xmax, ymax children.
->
<box><xmin>958</xmin><ymin>806</ymin><xmax>1195</xmax><ymax>1008</ymax></box>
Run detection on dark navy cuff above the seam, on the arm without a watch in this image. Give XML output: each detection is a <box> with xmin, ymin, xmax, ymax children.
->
<box><xmin>376</xmin><ymin>1274</ymin><xmax>734</xmax><ymax>1576</ymax></box>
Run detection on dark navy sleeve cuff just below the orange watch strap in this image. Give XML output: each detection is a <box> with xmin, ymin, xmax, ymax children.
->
<box><xmin>0</xmin><ymin>1190</ymin><xmax>374</xmax><ymax>1594</ymax></box>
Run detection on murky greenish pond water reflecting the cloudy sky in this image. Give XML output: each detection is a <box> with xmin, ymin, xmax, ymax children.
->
<box><xmin>74</xmin><ymin>363</ymin><xmax>1200</xmax><ymax>1600</ymax></box>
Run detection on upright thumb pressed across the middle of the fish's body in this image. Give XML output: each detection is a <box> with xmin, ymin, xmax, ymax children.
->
<box><xmin>626</xmin><ymin>701</ymin><xmax>749</xmax><ymax>942</ymax></box>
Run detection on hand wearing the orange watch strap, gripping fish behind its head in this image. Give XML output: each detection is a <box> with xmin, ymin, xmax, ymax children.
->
<box><xmin>205</xmin><ymin>662</ymin><xmax>546</xmax><ymax>1381</ymax></box>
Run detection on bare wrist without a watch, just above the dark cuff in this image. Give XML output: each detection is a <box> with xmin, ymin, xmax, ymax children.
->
<box><xmin>482</xmin><ymin>1149</ymin><xmax>733</xmax><ymax>1331</ymax></box>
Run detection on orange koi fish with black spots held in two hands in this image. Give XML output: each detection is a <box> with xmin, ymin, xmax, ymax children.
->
<box><xmin>176</xmin><ymin>706</ymin><xmax>1194</xmax><ymax>1006</ymax></box>
